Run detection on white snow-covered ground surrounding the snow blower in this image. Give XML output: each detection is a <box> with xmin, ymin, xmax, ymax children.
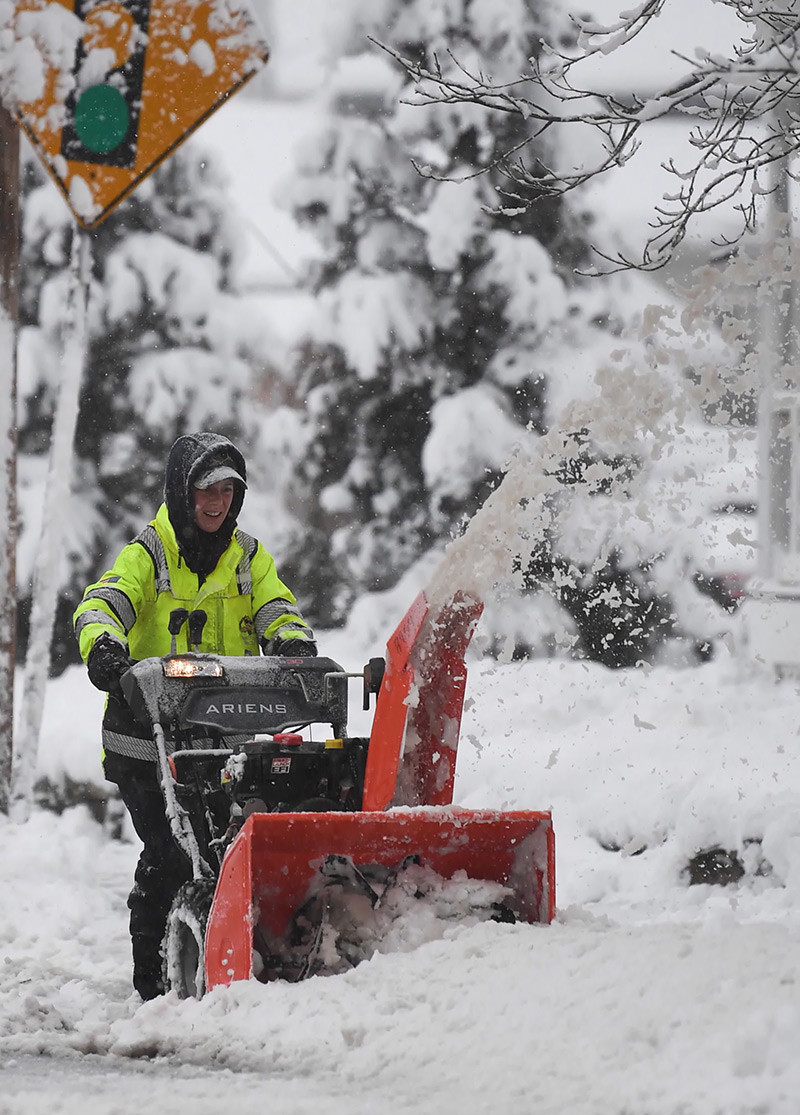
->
<box><xmin>0</xmin><ymin>615</ymin><xmax>800</xmax><ymax>1115</ymax></box>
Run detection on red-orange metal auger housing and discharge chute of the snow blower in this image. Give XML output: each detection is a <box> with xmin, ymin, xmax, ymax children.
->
<box><xmin>205</xmin><ymin>594</ymin><xmax>556</xmax><ymax>988</ymax></box>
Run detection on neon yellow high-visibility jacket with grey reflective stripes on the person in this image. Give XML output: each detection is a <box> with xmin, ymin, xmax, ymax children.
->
<box><xmin>74</xmin><ymin>504</ymin><xmax>314</xmax><ymax>661</ymax></box>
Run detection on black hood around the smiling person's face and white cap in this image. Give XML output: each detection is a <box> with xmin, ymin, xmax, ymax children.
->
<box><xmin>164</xmin><ymin>433</ymin><xmax>247</xmax><ymax>578</ymax></box>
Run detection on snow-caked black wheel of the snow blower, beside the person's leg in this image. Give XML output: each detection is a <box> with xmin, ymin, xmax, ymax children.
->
<box><xmin>163</xmin><ymin>879</ymin><xmax>215</xmax><ymax>999</ymax></box>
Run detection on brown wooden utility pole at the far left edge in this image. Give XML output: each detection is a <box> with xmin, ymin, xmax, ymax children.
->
<box><xmin>0</xmin><ymin>105</ymin><xmax>19</xmax><ymax>813</ymax></box>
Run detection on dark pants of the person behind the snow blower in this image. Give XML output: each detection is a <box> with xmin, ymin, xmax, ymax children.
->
<box><xmin>104</xmin><ymin>752</ymin><xmax>192</xmax><ymax>999</ymax></box>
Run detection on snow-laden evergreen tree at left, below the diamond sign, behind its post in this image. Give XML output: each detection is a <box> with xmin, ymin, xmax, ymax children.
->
<box><xmin>18</xmin><ymin>145</ymin><xmax>282</xmax><ymax>669</ymax></box>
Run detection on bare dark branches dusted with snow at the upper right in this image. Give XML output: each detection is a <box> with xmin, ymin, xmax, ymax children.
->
<box><xmin>377</xmin><ymin>0</ymin><xmax>800</xmax><ymax>271</ymax></box>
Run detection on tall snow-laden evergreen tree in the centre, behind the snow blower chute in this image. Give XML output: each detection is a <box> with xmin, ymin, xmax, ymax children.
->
<box><xmin>281</xmin><ymin>0</ymin><xmax>581</xmax><ymax>622</ymax></box>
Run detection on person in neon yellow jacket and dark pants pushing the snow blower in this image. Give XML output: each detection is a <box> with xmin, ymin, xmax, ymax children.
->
<box><xmin>74</xmin><ymin>433</ymin><xmax>317</xmax><ymax>999</ymax></box>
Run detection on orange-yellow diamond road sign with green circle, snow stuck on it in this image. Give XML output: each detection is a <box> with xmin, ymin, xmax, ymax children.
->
<box><xmin>11</xmin><ymin>0</ymin><xmax>268</xmax><ymax>229</ymax></box>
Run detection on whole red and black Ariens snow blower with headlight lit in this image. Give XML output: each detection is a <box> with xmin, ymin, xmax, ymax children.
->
<box><xmin>123</xmin><ymin>594</ymin><xmax>555</xmax><ymax>997</ymax></box>
